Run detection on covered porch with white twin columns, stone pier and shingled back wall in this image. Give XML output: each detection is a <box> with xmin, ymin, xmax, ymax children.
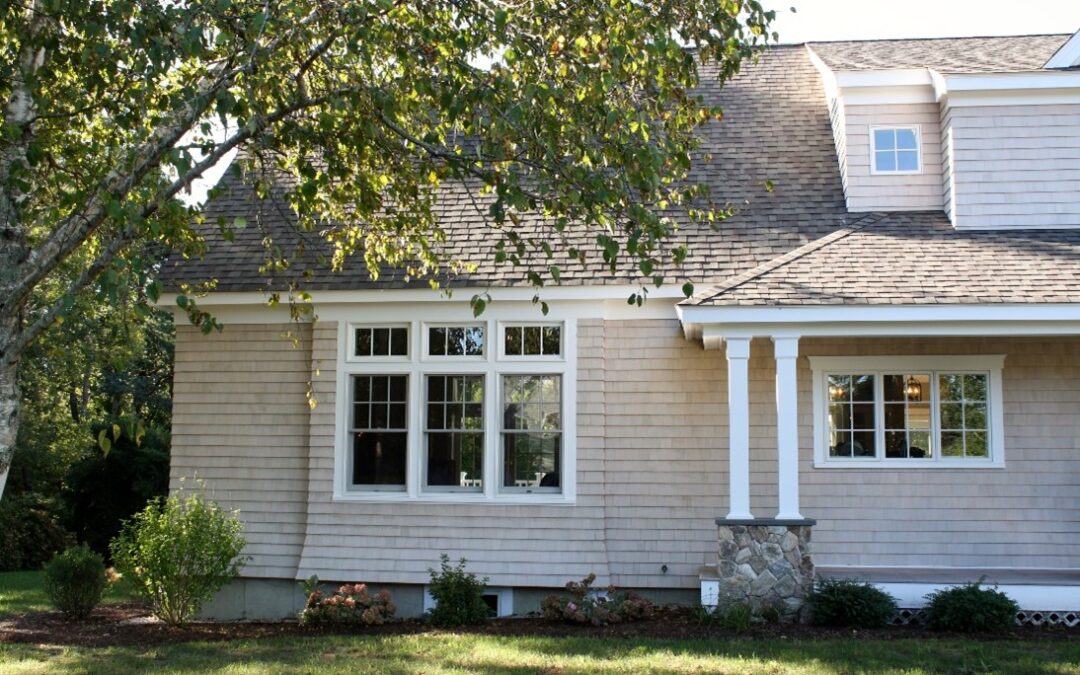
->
<box><xmin>679</xmin><ymin>306</ymin><xmax>1080</xmax><ymax>611</ymax></box>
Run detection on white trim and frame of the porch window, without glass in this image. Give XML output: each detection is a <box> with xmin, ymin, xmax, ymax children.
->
<box><xmin>809</xmin><ymin>354</ymin><xmax>1005</xmax><ymax>470</ymax></box>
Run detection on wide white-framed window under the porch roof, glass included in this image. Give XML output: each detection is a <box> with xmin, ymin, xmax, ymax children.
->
<box><xmin>810</xmin><ymin>356</ymin><xmax>1004</xmax><ymax>468</ymax></box>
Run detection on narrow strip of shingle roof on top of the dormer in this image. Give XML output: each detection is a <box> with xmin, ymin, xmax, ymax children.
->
<box><xmin>809</xmin><ymin>35</ymin><xmax>1071</xmax><ymax>73</ymax></box>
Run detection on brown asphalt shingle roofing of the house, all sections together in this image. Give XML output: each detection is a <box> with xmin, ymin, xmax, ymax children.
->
<box><xmin>162</xmin><ymin>36</ymin><xmax>1080</xmax><ymax>306</ymax></box>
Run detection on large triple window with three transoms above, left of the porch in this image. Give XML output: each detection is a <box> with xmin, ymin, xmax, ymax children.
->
<box><xmin>335</xmin><ymin>319</ymin><xmax>575</xmax><ymax>502</ymax></box>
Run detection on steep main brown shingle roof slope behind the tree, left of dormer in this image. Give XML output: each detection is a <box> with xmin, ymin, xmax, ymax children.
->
<box><xmin>163</xmin><ymin>45</ymin><xmax>849</xmax><ymax>291</ymax></box>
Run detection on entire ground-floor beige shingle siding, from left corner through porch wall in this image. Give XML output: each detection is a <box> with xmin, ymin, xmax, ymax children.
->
<box><xmin>166</xmin><ymin>320</ymin><xmax>1080</xmax><ymax>589</ymax></box>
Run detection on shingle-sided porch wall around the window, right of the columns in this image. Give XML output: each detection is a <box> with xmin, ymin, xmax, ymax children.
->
<box><xmin>794</xmin><ymin>337</ymin><xmax>1080</xmax><ymax>568</ymax></box>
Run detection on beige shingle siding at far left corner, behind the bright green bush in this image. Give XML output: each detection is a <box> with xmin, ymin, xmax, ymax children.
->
<box><xmin>170</xmin><ymin>321</ymin><xmax>311</xmax><ymax>578</ymax></box>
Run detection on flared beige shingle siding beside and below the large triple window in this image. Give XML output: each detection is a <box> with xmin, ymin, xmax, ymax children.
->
<box><xmin>299</xmin><ymin>322</ymin><xmax>608</xmax><ymax>586</ymax></box>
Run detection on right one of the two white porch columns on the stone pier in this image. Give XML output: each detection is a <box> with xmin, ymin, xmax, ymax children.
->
<box><xmin>772</xmin><ymin>337</ymin><xmax>802</xmax><ymax>521</ymax></box>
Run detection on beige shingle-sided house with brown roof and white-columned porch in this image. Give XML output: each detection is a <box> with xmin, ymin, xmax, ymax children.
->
<box><xmin>157</xmin><ymin>30</ymin><xmax>1080</xmax><ymax>624</ymax></box>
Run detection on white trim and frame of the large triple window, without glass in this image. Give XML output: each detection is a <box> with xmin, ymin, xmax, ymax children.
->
<box><xmin>334</xmin><ymin>313</ymin><xmax>578</xmax><ymax>505</ymax></box>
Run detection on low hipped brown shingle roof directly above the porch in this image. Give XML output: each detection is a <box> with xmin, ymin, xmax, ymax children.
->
<box><xmin>686</xmin><ymin>212</ymin><xmax>1080</xmax><ymax>306</ymax></box>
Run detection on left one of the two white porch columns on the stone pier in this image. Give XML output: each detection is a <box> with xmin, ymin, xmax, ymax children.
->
<box><xmin>724</xmin><ymin>337</ymin><xmax>754</xmax><ymax>519</ymax></box>
